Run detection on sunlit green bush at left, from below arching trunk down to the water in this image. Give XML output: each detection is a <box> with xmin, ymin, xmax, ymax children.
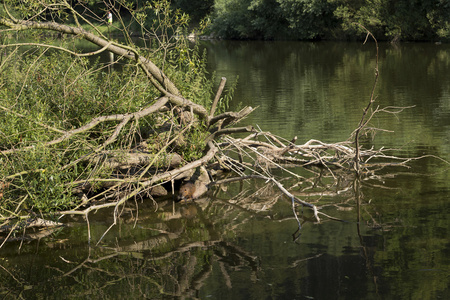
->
<box><xmin>0</xmin><ymin>45</ymin><xmax>148</xmax><ymax>212</ymax></box>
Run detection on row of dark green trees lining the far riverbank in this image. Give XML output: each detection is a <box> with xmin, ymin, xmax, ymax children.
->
<box><xmin>81</xmin><ymin>0</ymin><xmax>450</xmax><ymax>41</ymax></box>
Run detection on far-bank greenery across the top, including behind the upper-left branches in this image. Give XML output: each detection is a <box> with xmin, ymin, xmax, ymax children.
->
<box><xmin>0</xmin><ymin>0</ymin><xmax>450</xmax><ymax>42</ymax></box>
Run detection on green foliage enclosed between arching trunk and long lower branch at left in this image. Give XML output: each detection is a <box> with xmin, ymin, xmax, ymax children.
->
<box><xmin>0</xmin><ymin>45</ymin><xmax>151</xmax><ymax>139</ymax></box>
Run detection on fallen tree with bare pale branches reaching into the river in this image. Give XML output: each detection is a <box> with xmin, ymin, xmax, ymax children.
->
<box><xmin>0</xmin><ymin>0</ymin><xmax>422</xmax><ymax>244</ymax></box>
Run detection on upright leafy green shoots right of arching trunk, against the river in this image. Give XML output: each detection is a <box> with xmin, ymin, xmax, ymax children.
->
<box><xmin>127</xmin><ymin>0</ymin><xmax>217</xmax><ymax>108</ymax></box>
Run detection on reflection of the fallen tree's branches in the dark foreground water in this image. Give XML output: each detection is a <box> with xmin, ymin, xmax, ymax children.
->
<box><xmin>2</xmin><ymin>168</ymin><xmax>426</xmax><ymax>298</ymax></box>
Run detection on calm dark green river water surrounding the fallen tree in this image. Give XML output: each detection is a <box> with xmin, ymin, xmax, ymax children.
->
<box><xmin>0</xmin><ymin>41</ymin><xmax>450</xmax><ymax>299</ymax></box>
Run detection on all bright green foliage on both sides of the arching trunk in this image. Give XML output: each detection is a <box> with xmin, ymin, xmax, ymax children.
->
<box><xmin>0</xmin><ymin>0</ymin><xmax>224</xmax><ymax>215</ymax></box>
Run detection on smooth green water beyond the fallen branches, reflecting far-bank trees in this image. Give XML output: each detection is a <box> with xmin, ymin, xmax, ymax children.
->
<box><xmin>205</xmin><ymin>42</ymin><xmax>450</xmax><ymax>157</ymax></box>
